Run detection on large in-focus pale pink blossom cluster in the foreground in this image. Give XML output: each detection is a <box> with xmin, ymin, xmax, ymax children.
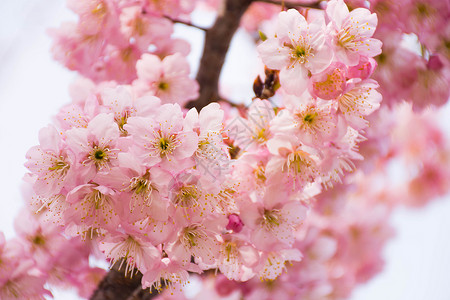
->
<box><xmin>12</xmin><ymin>1</ymin><xmax>381</xmax><ymax>296</ymax></box>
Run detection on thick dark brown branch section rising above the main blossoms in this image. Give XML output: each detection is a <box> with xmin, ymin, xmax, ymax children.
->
<box><xmin>186</xmin><ymin>0</ymin><xmax>253</xmax><ymax>110</ymax></box>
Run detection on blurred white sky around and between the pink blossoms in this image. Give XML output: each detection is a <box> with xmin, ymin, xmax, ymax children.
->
<box><xmin>0</xmin><ymin>0</ymin><xmax>450</xmax><ymax>300</ymax></box>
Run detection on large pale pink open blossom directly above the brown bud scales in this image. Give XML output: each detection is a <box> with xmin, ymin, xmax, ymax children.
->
<box><xmin>258</xmin><ymin>9</ymin><xmax>333</xmax><ymax>96</ymax></box>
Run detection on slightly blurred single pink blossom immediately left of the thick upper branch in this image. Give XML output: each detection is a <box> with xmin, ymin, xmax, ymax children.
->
<box><xmin>133</xmin><ymin>54</ymin><xmax>199</xmax><ymax>104</ymax></box>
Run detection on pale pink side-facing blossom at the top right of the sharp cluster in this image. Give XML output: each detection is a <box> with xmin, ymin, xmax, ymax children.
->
<box><xmin>326</xmin><ymin>0</ymin><xmax>382</xmax><ymax>66</ymax></box>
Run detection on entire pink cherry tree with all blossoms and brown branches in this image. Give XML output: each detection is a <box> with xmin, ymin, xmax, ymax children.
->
<box><xmin>0</xmin><ymin>0</ymin><xmax>450</xmax><ymax>300</ymax></box>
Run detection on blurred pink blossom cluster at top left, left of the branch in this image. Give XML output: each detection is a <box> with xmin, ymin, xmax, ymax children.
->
<box><xmin>50</xmin><ymin>0</ymin><xmax>195</xmax><ymax>85</ymax></box>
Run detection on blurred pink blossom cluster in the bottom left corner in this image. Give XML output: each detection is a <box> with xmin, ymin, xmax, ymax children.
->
<box><xmin>0</xmin><ymin>209</ymin><xmax>105</xmax><ymax>300</ymax></box>
